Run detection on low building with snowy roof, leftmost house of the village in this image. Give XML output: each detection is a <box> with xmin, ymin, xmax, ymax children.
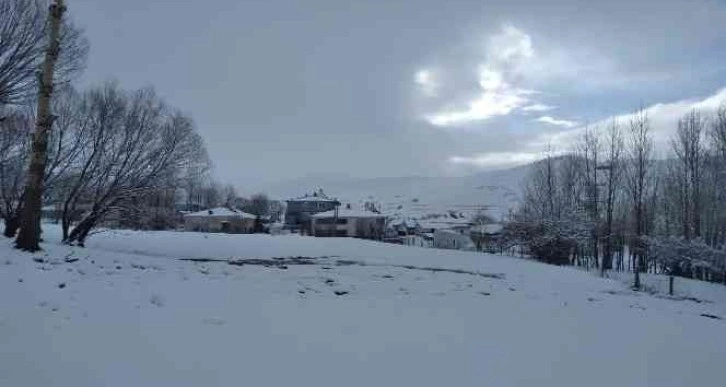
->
<box><xmin>184</xmin><ymin>207</ymin><xmax>256</xmax><ymax>234</ymax></box>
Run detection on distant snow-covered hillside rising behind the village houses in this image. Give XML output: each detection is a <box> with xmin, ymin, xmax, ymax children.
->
<box><xmin>268</xmin><ymin>166</ymin><xmax>528</xmax><ymax>218</ymax></box>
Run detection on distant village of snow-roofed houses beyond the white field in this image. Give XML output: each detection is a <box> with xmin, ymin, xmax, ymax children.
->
<box><xmin>168</xmin><ymin>189</ymin><xmax>502</xmax><ymax>252</ymax></box>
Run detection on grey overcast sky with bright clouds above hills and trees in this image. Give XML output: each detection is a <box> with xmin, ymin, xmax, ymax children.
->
<box><xmin>68</xmin><ymin>0</ymin><xmax>726</xmax><ymax>193</ymax></box>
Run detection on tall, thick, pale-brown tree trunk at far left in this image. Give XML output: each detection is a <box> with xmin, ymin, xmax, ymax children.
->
<box><xmin>15</xmin><ymin>0</ymin><xmax>66</xmax><ymax>251</ymax></box>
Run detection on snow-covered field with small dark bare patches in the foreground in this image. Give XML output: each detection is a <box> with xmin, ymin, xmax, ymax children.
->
<box><xmin>0</xmin><ymin>225</ymin><xmax>726</xmax><ymax>387</ymax></box>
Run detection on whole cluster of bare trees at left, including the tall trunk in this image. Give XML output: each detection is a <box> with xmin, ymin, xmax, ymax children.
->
<box><xmin>0</xmin><ymin>0</ymin><xmax>216</xmax><ymax>251</ymax></box>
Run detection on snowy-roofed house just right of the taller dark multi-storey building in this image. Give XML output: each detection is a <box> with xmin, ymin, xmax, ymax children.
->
<box><xmin>311</xmin><ymin>206</ymin><xmax>386</xmax><ymax>239</ymax></box>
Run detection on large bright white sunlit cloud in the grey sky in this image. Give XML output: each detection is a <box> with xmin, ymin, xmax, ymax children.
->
<box><xmin>424</xmin><ymin>26</ymin><xmax>535</xmax><ymax>126</ymax></box>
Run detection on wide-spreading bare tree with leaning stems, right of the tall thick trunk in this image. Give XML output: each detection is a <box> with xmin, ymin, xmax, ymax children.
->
<box><xmin>48</xmin><ymin>84</ymin><xmax>200</xmax><ymax>245</ymax></box>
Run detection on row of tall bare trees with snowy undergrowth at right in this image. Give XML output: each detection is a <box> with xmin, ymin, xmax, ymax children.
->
<box><xmin>505</xmin><ymin>104</ymin><xmax>726</xmax><ymax>287</ymax></box>
